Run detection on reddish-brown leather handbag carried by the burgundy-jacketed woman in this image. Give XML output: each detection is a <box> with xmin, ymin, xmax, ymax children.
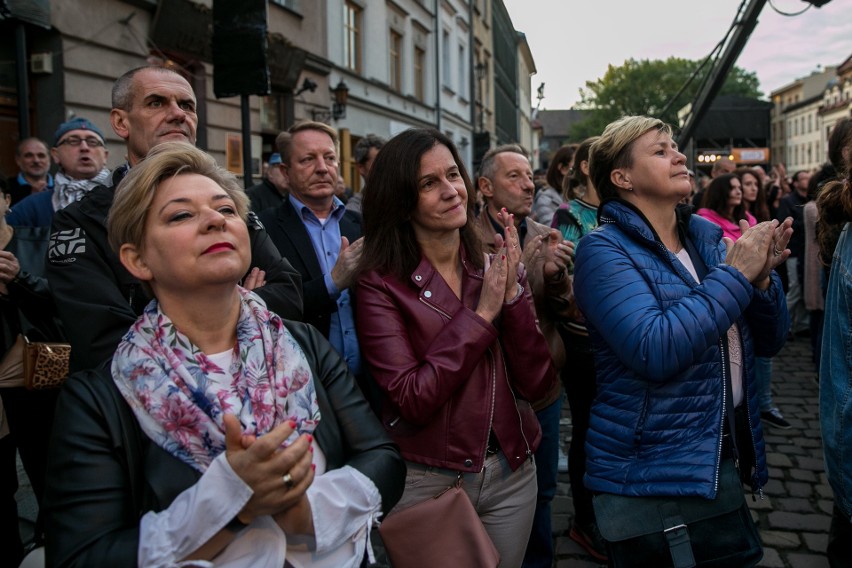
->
<box><xmin>379</xmin><ymin>476</ymin><xmax>500</xmax><ymax>568</ymax></box>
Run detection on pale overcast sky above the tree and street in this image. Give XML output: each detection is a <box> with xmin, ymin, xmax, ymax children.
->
<box><xmin>503</xmin><ymin>0</ymin><xmax>852</xmax><ymax>110</ymax></box>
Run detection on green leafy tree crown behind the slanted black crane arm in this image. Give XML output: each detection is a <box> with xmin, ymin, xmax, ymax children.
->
<box><xmin>571</xmin><ymin>57</ymin><xmax>762</xmax><ymax>140</ymax></box>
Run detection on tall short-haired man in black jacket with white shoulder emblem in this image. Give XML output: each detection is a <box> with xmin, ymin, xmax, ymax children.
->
<box><xmin>47</xmin><ymin>67</ymin><xmax>303</xmax><ymax>372</ymax></box>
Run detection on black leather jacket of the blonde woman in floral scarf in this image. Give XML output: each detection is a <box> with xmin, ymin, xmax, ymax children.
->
<box><xmin>44</xmin><ymin>320</ymin><xmax>405</xmax><ymax>567</ymax></box>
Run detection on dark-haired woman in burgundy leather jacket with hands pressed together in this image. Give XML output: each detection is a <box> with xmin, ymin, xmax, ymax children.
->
<box><xmin>356</xmin><ymin>129</ymin><xmax>556</xmax><ymax>566</ymax></box>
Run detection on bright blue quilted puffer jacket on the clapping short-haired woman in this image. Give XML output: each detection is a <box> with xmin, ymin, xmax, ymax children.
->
<box><xmin>569</xmin><ymin>201</ymin><xmax>790</xmax><ymax>499</ymax></box>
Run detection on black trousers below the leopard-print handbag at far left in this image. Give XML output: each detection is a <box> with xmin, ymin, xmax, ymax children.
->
<box><xmin>0</xmin><ymin>387</ymin><xmax>59</xmax><ymax>542</ymax></box>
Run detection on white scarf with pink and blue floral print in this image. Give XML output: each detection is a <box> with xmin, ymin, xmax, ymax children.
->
<box><xmin>112</xmin><ymin>288</ymin><xmax>320</xmax><ymax>472</ymax></box>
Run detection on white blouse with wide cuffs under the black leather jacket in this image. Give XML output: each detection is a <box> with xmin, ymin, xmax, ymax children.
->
<box><xmin>137</xmin><ymin>351</ymin><xmax>382</xmax><ymax>568</ymax></box>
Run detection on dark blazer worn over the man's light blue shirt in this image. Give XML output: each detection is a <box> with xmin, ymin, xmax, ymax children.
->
<box><xmin>258</xmin><ymin>199</ymin><xmax>361</xmax><ymax>338</ymax></box>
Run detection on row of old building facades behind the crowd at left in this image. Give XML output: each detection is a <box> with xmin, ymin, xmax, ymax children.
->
<box><xmin>0</xmin><ymin>0</ymin><xmax>534</xmax><ymax>184</ymax></box>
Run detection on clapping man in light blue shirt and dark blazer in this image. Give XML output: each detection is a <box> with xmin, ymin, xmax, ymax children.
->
<box><xmin>260</xmin><ymin>122</ymin><xmax>363</xmax><ymax>376</ymax></box>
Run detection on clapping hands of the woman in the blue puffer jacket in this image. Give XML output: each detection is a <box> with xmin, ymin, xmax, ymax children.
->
<box><xmin>724</xmin><ymin>217</ymin><xmax>793</xmax><ymax>289</ymax></box>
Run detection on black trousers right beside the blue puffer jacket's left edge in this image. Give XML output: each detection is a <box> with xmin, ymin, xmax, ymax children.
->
<box><xmin>562</xmin><ymin>332</ymin><xmax>597</xmax><ymax>526</ymax></box>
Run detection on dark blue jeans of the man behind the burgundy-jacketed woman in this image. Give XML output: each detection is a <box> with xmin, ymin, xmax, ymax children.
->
<box><xmin>523</xmin><ymin>397</ymin><xmax>562</xmax><ymax>568</ymax></box>
